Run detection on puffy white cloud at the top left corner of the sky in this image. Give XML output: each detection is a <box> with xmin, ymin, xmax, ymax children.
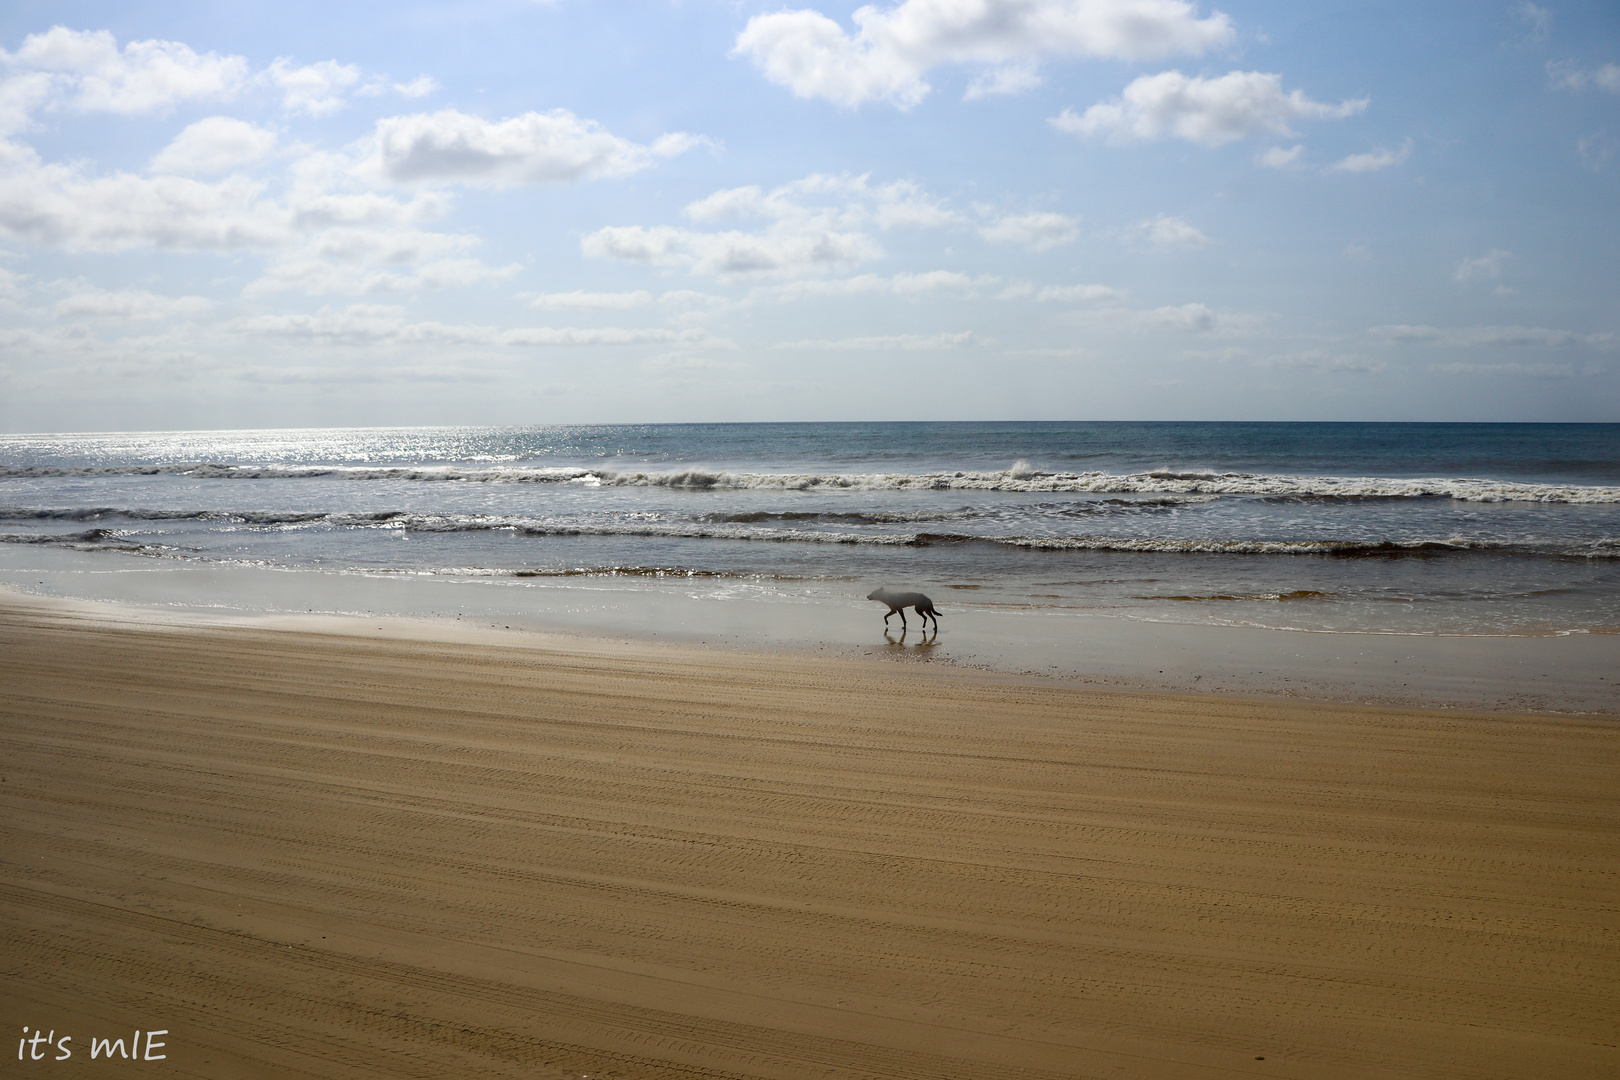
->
<box><xmin>0</xmin><ymin>26</ymin><xmax>248</xmax><ymax>115</ymax></box>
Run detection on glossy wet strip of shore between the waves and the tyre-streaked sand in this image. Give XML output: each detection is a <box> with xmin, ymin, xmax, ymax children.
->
<box><xmin>0</xmin><ymin>582</ymin><xmax>1620</xmax><ymax>717</ymax></box>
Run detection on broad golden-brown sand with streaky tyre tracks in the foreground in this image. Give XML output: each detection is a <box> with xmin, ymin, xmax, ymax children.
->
<box><xmin>0</xmin><ymin>599</ymin><xmax>1620</xmax><ymax>1080</ymax></box>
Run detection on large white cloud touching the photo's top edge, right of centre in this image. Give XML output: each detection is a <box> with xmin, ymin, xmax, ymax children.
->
<box><xmin>732</xmin><ymin>0</ymin><xmax>1234</xmax><ymax>108</ymax></box>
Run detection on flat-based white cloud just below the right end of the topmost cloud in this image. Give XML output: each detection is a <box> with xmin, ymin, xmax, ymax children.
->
<box><xmin>1051</xmin><ymin>71</ymin><xmax>1369</xmax><ymax>146</ymax></box>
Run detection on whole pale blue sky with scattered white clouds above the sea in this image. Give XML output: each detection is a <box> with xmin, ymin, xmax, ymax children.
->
<box><xmin>0</xmin><ymin>0</ymin><xmax>1620</xmax><ymax>432</ymax></box>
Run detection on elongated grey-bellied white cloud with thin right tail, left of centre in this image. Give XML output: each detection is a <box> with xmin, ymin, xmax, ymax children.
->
<box><xmin>366</xmin><ymin>108</ymin><xmax>698</xmax><ymax>188</ymax></box>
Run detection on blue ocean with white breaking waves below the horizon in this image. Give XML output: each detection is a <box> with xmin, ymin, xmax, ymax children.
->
<box><xmin>0</xmin><ymin>423</ymin><xmax>1620</xmax><ymax>636</ymax></box>
